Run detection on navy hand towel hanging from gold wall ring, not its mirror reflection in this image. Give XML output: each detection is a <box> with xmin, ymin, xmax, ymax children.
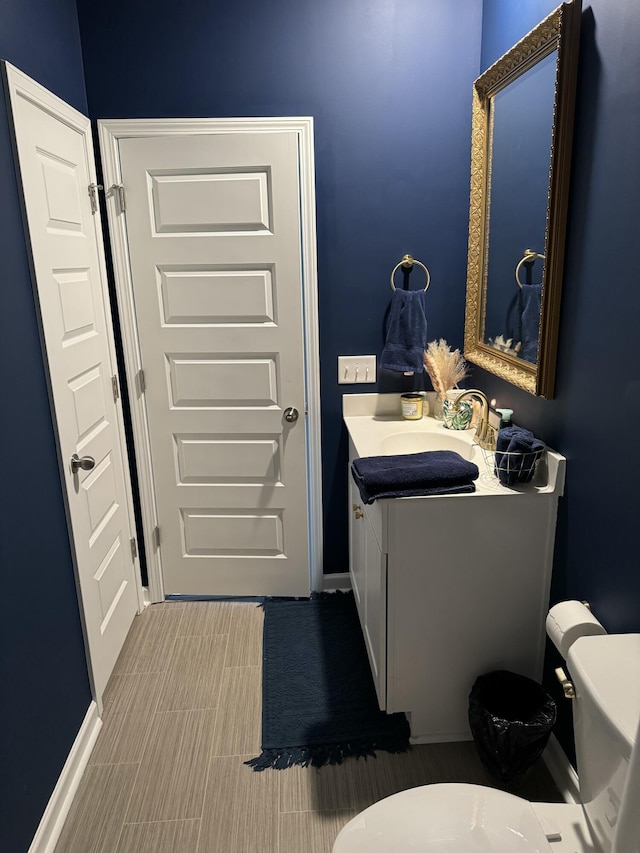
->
<box><xmin>380</xmin><ymin>290</ymin><xmax>427</xmax><ymax>373</ymax></box>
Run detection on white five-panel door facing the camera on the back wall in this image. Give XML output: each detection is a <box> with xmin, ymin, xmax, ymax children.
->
<box><xmin>119</xmin><ymin>131</ymin><xmax>309</xmax><ymax>595</ymax></box>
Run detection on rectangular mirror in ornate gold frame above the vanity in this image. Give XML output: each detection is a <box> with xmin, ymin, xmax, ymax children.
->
<box><xmin>464</xmin><ymin>0</ymin><xmax>581</xmax><ymax>399</ymax></box>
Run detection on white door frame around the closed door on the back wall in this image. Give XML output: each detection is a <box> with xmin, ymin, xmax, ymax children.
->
<box><xmin>98</xmin><ymin>116</ymin><xmax>323</xmax><ymax>601</ymax></box>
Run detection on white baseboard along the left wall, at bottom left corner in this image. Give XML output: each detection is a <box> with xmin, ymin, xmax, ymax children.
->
<box><xmin>29</xmin><ymin>702</ymin><xmax>102</xmax><ymax>853</ymax></box>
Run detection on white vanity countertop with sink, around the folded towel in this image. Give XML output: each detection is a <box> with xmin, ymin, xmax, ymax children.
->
<box><xmin>342</xmin><ymin>394</ymin><xmax>566</xmax><ymax>500</ymax></box>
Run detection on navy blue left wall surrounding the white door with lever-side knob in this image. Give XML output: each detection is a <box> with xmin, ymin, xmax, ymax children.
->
<box><xmin>0</xmin><ymin>0</ymin><xmax>91</xmax><ymax>853</ymax></box>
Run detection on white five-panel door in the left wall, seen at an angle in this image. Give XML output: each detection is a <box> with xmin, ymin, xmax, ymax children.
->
<box><xmin>6</xmin><ymin>66</ymin><xmax>138</xmax><ymax>705</ymax></box>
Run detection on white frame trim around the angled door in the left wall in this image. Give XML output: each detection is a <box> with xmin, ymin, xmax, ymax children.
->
<box><xmin>1</xmin><ymin>62</ymin><xmax>145</xmax><ymax>696</ymax></box>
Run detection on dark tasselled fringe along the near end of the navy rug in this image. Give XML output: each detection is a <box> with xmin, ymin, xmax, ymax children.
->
<box><xmin>244</xmin><ymin>738</ymin><xmax>411</xmax><ymax>771</ymax></box>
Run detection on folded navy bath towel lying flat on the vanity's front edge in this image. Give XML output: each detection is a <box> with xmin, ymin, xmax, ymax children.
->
<box><xmin>351</xmin><ymin>450</ymin><xmax>479</xmax><ymax>504</ymax></box>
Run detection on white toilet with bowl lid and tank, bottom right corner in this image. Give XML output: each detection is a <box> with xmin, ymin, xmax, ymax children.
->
<box><xmin>333</xmin><ymin>634</ymin><xmax>640</xmax><ymax>853</ymax></box>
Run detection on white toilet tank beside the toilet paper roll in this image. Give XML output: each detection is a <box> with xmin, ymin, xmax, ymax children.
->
<box><xmin>567</xmin><ymin>634</ymin><xmax>640</xmax><ymax>853</ymax></box>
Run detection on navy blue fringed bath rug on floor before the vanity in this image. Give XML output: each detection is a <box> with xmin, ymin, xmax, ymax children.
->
<box><xmin>246</xmin><ymin>592</ymin><xmax>409</xmax><ymax>770</ymax></box>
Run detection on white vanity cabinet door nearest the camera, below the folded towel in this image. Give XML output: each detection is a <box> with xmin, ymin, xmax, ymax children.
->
<box><xmin>363</xmin><ymin>513</ymin><xmax>387</xmax><ymax>711</ymax></box>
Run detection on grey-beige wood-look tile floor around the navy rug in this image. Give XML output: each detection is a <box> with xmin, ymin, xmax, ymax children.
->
<box><xmin>55</xmin><ymin>601</ymin><xmax>561</xmax><ymax>853</ymax></box>
